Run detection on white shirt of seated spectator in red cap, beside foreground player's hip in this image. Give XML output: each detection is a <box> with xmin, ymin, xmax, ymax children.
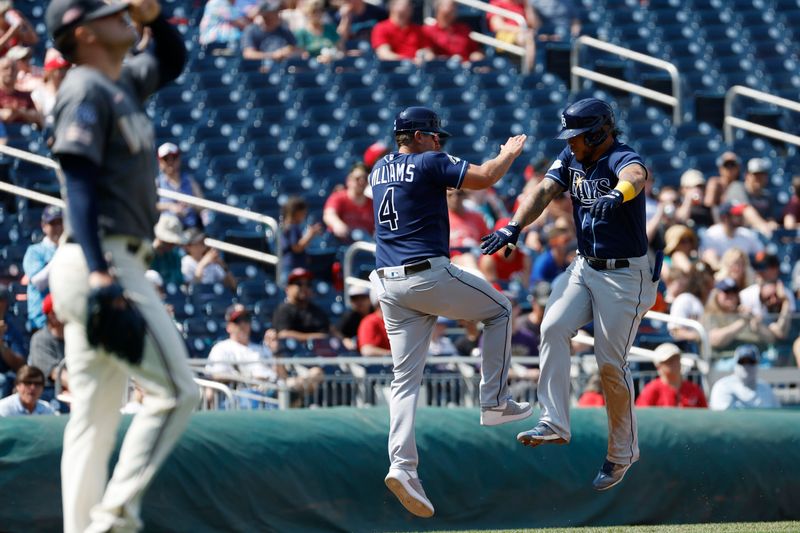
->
<box><xmin>205</xmin><ymin>339</ymin><xmax>278</xmax><ymax>383</ymax></box>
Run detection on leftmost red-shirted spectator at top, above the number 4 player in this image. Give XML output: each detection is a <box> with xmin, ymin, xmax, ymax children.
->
<box><xmin>372</xmin><ymin>0</ymin><xmax>433</xmax><ymax>63</ymax></box>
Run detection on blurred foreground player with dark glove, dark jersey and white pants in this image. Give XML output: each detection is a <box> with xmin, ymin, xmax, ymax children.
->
<box><xmin>46</xmin><ymin>0</ymin><xmax>199</xmax><ymax>533</ymax></box>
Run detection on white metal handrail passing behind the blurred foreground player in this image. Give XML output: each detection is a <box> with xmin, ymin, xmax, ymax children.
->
<box><xmin>0</xmin><ymin>145</ymin><xmax>282</xmax><ymax>283</ymax></box>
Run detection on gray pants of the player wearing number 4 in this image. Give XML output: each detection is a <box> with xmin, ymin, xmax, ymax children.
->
<box><xmin>370</xmin><ymin>257</ymin><xmax>511</xmax><ymax>470</ymax></box>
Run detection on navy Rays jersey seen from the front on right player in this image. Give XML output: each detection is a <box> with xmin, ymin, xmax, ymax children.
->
<box><xmin>545</xmin><ymin>141</ymin><xmax>647</xmax><ymax>259</ymax></box>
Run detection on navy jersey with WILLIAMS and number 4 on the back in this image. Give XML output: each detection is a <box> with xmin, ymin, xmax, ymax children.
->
<box><xmin>369</xmin><ymin>152</ymin><xmax>468</xmax><ymax>268</ymax></box>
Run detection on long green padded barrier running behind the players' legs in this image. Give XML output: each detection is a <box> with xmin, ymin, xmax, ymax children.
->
<box><xmin>0</xmin><ymin>408</ymin><xmax>800</xmax><ymax>532</ymax></box>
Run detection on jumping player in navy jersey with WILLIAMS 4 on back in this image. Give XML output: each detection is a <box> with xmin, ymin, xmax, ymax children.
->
<box><xmin>369</xmin><ymin>107</ymin><xmax>531</xmax><ymax>518</ymax></box>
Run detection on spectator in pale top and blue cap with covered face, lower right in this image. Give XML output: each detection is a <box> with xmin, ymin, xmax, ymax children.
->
<box><xmin>710</xmin><ymin>344</ymin><xmax>781</xmax><ymax>411</ymax></box>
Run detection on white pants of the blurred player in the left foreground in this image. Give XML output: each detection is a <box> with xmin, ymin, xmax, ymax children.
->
<box><xmin>50</xmin><ymin>237</ymin><xmax>199</xmax><ymax>533</ymax></box>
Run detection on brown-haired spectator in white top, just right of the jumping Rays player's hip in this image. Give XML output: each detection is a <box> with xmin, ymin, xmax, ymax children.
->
<box><xmin>667</xmin><ymin>262</ymin><xmax>714</xmax><ymax>343</ymax></box>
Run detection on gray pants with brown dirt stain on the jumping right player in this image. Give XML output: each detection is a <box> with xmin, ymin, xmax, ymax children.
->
<box><xmin>538</xmin><ymin>256</ymin><xmax>656</xmax><ymax>464</ymax></box>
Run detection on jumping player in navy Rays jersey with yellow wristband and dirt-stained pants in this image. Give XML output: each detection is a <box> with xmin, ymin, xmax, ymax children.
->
<box><xmin>481</xmin><ymin>98</ymin><xmax>660</xmax><ymax>490</ymax></box>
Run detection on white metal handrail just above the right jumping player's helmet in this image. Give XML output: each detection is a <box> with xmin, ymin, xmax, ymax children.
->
<box><xmin>568</xmin><ymin>35</ymin><xmax>683</xmax><ymax>126</ymax></box>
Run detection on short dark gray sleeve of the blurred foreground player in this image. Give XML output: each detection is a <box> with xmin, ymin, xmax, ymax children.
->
<box><xmin>52</xmin><ymin>80</ymin><xmax>111</xmax><ymax>166</ymax></box>
